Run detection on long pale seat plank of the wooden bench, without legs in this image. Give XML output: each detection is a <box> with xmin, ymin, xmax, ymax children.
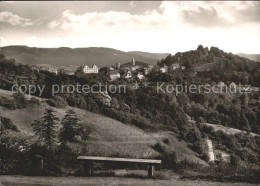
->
<box><xmin>77</xmin><ymin>156</ymin><xmax>161</xmax><ymax>164</ymax></box>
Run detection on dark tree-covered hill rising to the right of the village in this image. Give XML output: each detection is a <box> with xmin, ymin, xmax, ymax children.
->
<box><xmin>159</xmin><ymin>45</ymin><xmax>260</xmax><ymax>87</ymax></box>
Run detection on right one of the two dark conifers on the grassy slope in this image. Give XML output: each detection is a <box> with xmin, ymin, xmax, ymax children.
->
<box><xmin>59</xmin><ymin>110</ymin><xmax>81</xmax><ymax>145</ymax></box>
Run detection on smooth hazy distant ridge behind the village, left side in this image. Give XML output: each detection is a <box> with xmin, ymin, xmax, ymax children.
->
<box><xmin>1</xmin><ymin>46</ymin><xmax>164</xmax><ymax>70</ymax></box>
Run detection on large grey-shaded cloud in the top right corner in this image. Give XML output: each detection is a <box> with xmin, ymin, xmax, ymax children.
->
<box><xmin>160</xmin><ymin>1</ymin><xmax>260</xmax><ymax>28</ymax></box>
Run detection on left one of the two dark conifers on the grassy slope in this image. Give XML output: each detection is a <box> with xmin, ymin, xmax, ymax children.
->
<box><xmin>32</xmin><ymin>109</ymin><xmax>59</xmax><ymax>149</ymax></box>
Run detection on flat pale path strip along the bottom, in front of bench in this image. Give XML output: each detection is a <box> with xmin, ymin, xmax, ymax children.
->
<box><xmin>0</xmin><ymin>176</ymin><xmax>253</xmax><ymax>186</ymax></box>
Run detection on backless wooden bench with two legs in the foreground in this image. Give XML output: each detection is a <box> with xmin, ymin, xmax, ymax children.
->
<box><xmin>77</xmin><ymin>156</ymin><xmax>162</xmax><ymax>178</ymax></box>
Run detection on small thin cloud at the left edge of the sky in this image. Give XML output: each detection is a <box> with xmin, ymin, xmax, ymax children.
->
<box><xmin>0</xmin><ymin>11</ymin><xmax>34</xmax><ymax>27</ymax></box>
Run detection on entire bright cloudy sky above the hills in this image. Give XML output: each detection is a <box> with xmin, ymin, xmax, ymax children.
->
<box><xmin>0</xmin><ymin>1</ymin><xmax>260</xmax><ymax>54</ymax></box>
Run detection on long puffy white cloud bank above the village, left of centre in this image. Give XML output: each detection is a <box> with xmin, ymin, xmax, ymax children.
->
<box><xmin>59</xmin><ymin>10</ymin><xmax>166</xmax><ymax>33</ymax></box>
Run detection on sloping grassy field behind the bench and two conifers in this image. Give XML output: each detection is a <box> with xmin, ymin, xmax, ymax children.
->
<box><xmin>0</xmin><ymin>102</ymin><xmax>205</xmax><ymax>164</ymax></box>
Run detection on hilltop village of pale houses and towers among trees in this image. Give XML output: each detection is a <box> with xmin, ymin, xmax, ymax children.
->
<box><xmin>33</xmin><ymin>54</ymin><xmax>259</xmax><ymax>94</ymax></box>
